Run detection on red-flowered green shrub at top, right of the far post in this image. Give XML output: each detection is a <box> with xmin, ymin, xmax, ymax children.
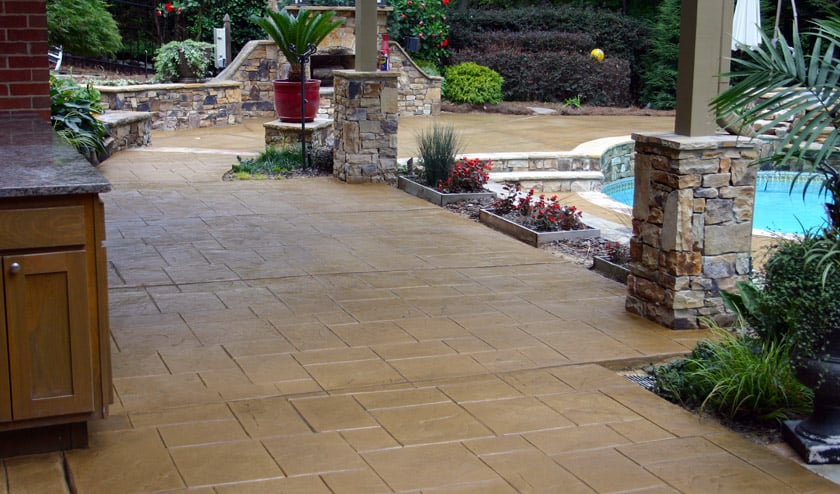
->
<box><xmin>390</xmin><ymin>0</ymin><xmax>449</xmax><ymax>66</ymax></box>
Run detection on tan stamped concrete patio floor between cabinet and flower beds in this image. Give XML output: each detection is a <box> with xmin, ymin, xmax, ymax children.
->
<box><xmin>0</xmin><ymin>115</ymin><xmax>838</xmax><ymax>494</ymax></box>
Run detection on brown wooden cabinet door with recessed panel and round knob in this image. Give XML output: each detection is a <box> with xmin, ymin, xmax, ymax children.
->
<box><xmin>3</xmin><ymin>251</ymin><xmax>94</xmax><ymax>420</ymax></box>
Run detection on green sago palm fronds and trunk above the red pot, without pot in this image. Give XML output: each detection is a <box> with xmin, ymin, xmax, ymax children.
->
<box><xmin>251</xmin><ymin>8</ymin><xmax>344</xmax><ymax>80</ymax></box>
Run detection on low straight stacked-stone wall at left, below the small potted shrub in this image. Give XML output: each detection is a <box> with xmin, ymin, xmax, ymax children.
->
<box><xmin>97</xmin><ymin>82</ymin><xmax>242</xmax><ymax>130</ymax></box>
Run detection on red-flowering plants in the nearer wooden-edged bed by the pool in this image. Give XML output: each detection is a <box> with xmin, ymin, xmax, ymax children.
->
<box><xmin>493</xmin><ymin>184</ymin><xmax>584</xmax><ymax>232</ymax></box>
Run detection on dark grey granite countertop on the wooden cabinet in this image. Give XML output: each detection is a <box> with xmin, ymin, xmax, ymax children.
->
<box><xmin>0</xmin><ymin>121</ymin><xmax>111</xmax><ymax>197</ymax></box>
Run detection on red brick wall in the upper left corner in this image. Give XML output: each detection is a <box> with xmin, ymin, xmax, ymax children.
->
<box><xmin>0</xmin><ymin>0</ymin><xmax>50</xmax><ymax>120</ymax></box>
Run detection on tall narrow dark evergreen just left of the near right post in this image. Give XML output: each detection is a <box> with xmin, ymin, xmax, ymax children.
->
<box><xmin>641</xmin><ymin>0</ymin><xmax>682</xmax><ymax>109</ymax></box>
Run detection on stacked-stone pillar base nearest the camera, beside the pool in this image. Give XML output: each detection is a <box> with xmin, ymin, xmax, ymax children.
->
<box><xmin>626</xmin><ymin>134</ymin><xmax>757</xmax><ymax>329</ymax></box>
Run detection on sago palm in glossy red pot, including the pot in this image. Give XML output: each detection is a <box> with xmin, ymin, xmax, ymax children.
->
<box><xmin>251</xmin><ymin>8</ymin><xmax>344</xmax><ymax>122</ymax></box>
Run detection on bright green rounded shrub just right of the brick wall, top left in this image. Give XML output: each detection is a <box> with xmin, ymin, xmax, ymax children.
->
<box><xmin>47</xmin><ymin>0</ymin><xmax>122</xmax><ymax>56</ymax></box>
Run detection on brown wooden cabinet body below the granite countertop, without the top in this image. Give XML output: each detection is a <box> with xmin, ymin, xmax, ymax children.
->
<box><xmin>0</xmin><ymin>194</ymin><xmax>111</xmax><ymax>431</ymax></box>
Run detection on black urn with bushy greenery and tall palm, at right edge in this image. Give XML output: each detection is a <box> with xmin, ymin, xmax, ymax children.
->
<box><xmin>712</xmin><ymin>14</ymin><xmax>840</xmax><ymax>463</ymax></box>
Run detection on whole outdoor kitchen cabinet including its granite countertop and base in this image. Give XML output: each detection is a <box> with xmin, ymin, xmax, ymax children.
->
<box><xmin>0</xmin><ymin>127</ymin><xmax>113</xmax><ymax>457</ymax></box>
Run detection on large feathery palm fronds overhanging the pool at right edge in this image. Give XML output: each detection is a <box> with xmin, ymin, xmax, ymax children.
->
<box><xmin>712</xmin><ymin>13</ymin><xmax>840</xmax><ymax>230</ymax></box>
